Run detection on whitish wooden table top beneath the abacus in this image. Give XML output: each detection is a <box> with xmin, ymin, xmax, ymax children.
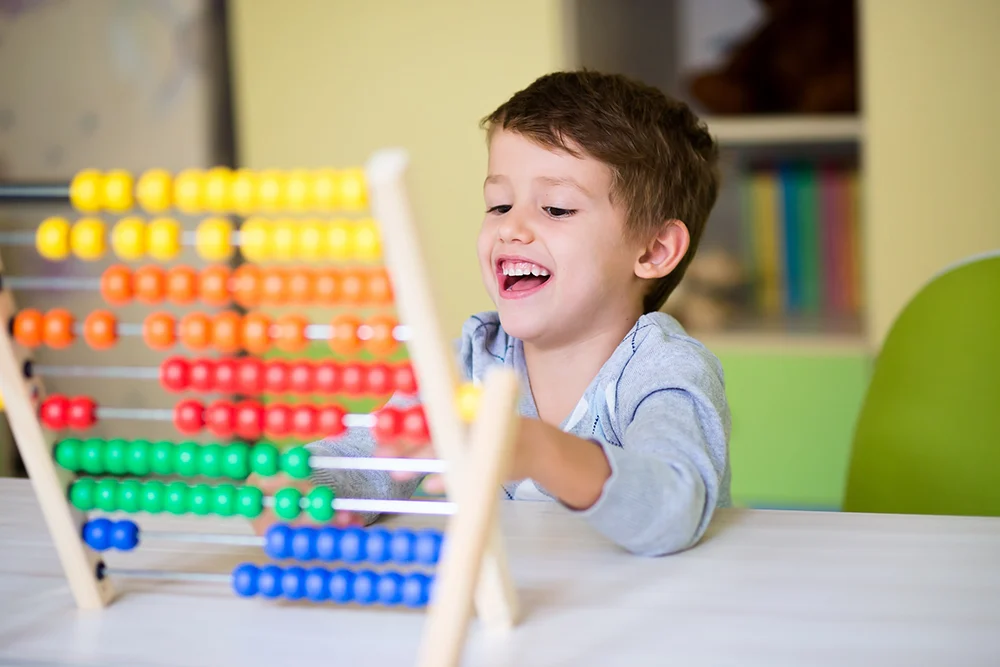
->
<box><xmin>0</xmin><ymin>479</ymin><xmax>1000</xmax><ymax>667</ymax></box>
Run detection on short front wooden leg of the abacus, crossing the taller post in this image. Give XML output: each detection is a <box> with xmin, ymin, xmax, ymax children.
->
<box><xmin>417</xmin><ymin>369</ymin><xmax>518</xmax><ymax>667</ymax></box>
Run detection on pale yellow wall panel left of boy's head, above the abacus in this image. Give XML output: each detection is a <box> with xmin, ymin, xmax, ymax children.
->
<box><xmin>231</xmin><ymin>0</ymin><xmax>563</xmax><ymax>336</ymax></box>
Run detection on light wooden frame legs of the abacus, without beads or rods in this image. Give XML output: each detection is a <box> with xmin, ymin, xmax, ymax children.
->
<box><xmin>0</xmin><ymin>149</ymin><xmax>519</xmax><ymax>667</ymax></box>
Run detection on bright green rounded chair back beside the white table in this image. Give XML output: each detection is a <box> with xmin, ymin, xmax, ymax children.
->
<box><xmin>843</xmin><ymin>253</ymin><xmax>1000</xmax><ymax>516</ymax></box>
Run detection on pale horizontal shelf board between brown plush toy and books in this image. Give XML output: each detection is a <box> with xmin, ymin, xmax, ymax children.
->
<box><xmin>704</xmin><ymin>116</ymin><xmax>864</xmax><ymax>145</ymax></box>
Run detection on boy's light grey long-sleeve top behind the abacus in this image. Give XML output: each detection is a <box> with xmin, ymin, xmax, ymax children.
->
<box><xmin>308</xmin><ymin>312</ymin><xmax>731</xmax><ymax>556</ymax></box>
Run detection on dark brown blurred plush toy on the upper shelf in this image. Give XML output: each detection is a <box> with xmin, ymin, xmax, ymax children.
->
<box><xmin>689</xmin><ymin>0</ymin><xmax>858</xmax><ymax>115</ymax></box>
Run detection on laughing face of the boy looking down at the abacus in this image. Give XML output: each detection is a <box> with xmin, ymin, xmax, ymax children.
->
<box><xmin>478</xmin><ymin>130</ymin><xmax>641</xmax><ymax>346</ymax></box>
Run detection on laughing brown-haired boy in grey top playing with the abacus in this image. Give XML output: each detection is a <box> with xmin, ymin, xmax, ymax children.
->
<box><xmin>292</xmin><ymin>72</ymin><xmax>730</xmax><ymax>556</ymax></box>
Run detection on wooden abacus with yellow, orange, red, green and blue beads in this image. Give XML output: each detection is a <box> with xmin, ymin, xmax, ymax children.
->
<box><xmin>0</xmin><ymin>149</ymin><xmax>518</xmax><ymax>666</ymax></box>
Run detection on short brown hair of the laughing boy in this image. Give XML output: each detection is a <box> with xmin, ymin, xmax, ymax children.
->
<box><xmin>480</xmin><ymin>70</ymin><xmax>719</xmax><ymax>313</ymax></box>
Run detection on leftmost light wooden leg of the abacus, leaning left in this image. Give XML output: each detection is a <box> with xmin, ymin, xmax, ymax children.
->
<box><xmin>0</xmin><ymin>258</ymin><xmax>114</xmax><ymax>609</ymax></box>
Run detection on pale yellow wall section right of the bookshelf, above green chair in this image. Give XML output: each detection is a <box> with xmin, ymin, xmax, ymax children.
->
<box><xmin>862</xmin><ymin>0</ymin><xmax>1000</xmax><ymax>343</ymax></box>
